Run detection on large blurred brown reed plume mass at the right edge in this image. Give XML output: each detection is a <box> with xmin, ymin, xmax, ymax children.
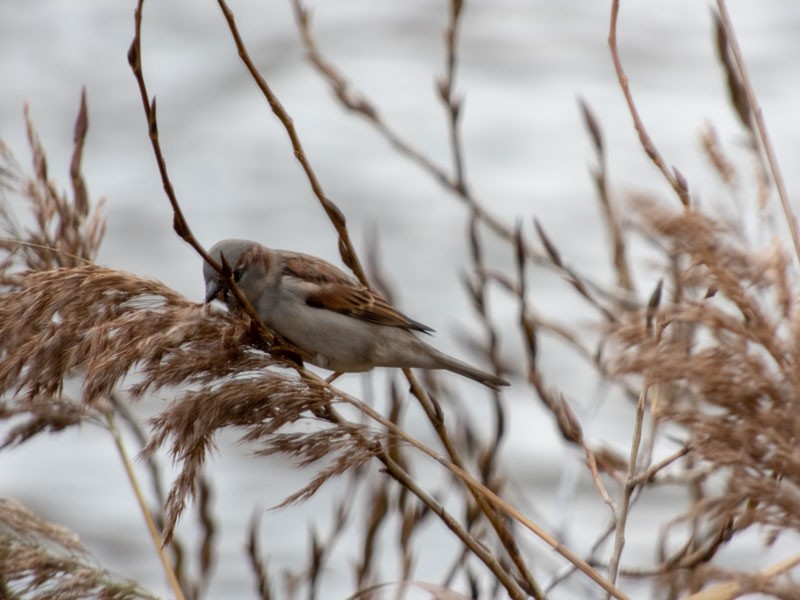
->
<box><xmin>610</xmin><ymin>198</ymin><xmax>800</xmax><ymax>584</ymax></box>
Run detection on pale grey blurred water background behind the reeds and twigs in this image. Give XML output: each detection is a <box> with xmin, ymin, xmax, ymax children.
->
<box><xmin>0</xmin><ymin>0</ymin><xmax>800</xmax><ymax>597</ymax></box>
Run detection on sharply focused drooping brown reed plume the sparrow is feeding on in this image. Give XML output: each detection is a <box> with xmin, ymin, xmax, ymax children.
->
<box><xmin>0</xmin><ymin>265</ymin><xmax>386</xmax><ymax>540</ymax></box>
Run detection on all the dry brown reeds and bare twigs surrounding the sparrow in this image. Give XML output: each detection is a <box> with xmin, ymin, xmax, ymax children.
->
<box><xmin>0</xmin><ymin>0</ymin><xmax>800</xmax><ymax>599</ymax></box>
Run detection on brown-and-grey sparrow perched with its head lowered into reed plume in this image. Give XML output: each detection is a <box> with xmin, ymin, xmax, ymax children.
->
<box><xmin>203</xmin><ymin>240</ymin><xmax>509</xmax><ymax>390</ymax></box>
